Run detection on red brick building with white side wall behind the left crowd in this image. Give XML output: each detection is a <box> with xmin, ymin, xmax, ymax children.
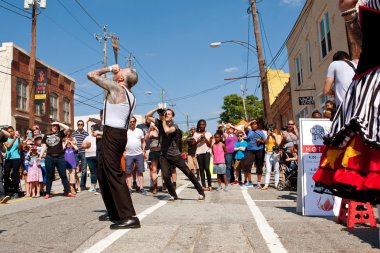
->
<box><xmin>0</xmin><ymin>42</ymin><xmax>75</xmax><ymax>133</ymax></box>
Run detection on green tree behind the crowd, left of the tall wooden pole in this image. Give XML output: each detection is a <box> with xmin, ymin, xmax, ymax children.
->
<box><xmin>220</xmin><ymin>94</ymin><xmax>264</xmax><ymax>124</ymax></box>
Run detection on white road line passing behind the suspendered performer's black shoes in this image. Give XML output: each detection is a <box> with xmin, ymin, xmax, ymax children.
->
<box><xmin>83</xmin><ymin>184</ymin><xmax>188</xmax><ymax>253</ymax></box>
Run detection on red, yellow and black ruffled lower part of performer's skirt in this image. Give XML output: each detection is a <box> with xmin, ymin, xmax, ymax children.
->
<box><xmin>313</xmin><ymin>134</ymin><xmax>380</xmax><ymax>204</ymax></box>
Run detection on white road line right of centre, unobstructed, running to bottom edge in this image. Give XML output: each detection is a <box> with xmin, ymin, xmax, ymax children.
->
<box><xmin>241</xmin><ymin>189</ymin><xmax>287</xmax><ymax>253</ymax></box>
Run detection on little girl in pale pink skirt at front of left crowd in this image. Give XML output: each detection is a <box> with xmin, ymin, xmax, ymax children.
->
<box><xmin>25</xmin><ymin>146</ymin><xmax>43</xmax><ymax>198</ymax></box>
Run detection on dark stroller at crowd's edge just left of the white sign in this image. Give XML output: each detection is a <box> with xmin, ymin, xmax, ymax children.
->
<box><xmin>277</xmin><ymin>148</ymin><xmax>298</xmax><ymax>191</ymax></box>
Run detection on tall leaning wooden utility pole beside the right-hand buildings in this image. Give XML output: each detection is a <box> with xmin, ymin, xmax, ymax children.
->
<box><xmin>251</xmin><ymin>0</ymin><xmax>272</xmax><ymax>124</ymax></box>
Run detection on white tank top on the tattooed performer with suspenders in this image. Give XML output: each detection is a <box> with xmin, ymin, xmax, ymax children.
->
<box><xmin>103</xmin><ymin>87</ymin><xmax>136</xmax><ymax>129</ymax></box>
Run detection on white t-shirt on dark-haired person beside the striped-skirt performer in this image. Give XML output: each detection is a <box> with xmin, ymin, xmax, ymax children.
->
<box><xmin>327</xmin><ymin>61</ymin><xmax>357</xmax><ymax>107</ymax></box>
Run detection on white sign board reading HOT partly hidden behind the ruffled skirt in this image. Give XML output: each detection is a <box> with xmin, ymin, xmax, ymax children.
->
<box><xmin>298</xmin><ymin>119</ymin><xmax>341</xmax><ymax>216</ymax></box>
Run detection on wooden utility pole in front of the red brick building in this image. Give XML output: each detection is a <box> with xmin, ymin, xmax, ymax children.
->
<box><xmin>24</xmin><ymin>0</ymin><xmax>46</xmax><ymax>128</ymax></box>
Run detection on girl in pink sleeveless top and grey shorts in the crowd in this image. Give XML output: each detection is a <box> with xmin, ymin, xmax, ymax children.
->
<box><xmin>211</xmin><ymin>133</ymin><xmax>228</xmax><ymax>191</ymax></box>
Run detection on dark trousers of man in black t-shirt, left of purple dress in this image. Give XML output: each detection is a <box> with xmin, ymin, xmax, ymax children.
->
<box><xmin>45</xmin><ymin>155</ymin><xmax>70</xmax><ymax>195</ymax></box>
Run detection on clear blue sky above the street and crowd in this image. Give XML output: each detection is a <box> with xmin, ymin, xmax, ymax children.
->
<box><xmin>0</xmin><ymin>0</ymin><xmax>305</xmax><ymax>131</ymax></box>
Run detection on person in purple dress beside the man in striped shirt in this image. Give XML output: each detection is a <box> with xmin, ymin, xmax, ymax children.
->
<box><xmin>63</xmin><ymin>133</ymin><xmax>78</xmax><ymax>194</ymax></box>
